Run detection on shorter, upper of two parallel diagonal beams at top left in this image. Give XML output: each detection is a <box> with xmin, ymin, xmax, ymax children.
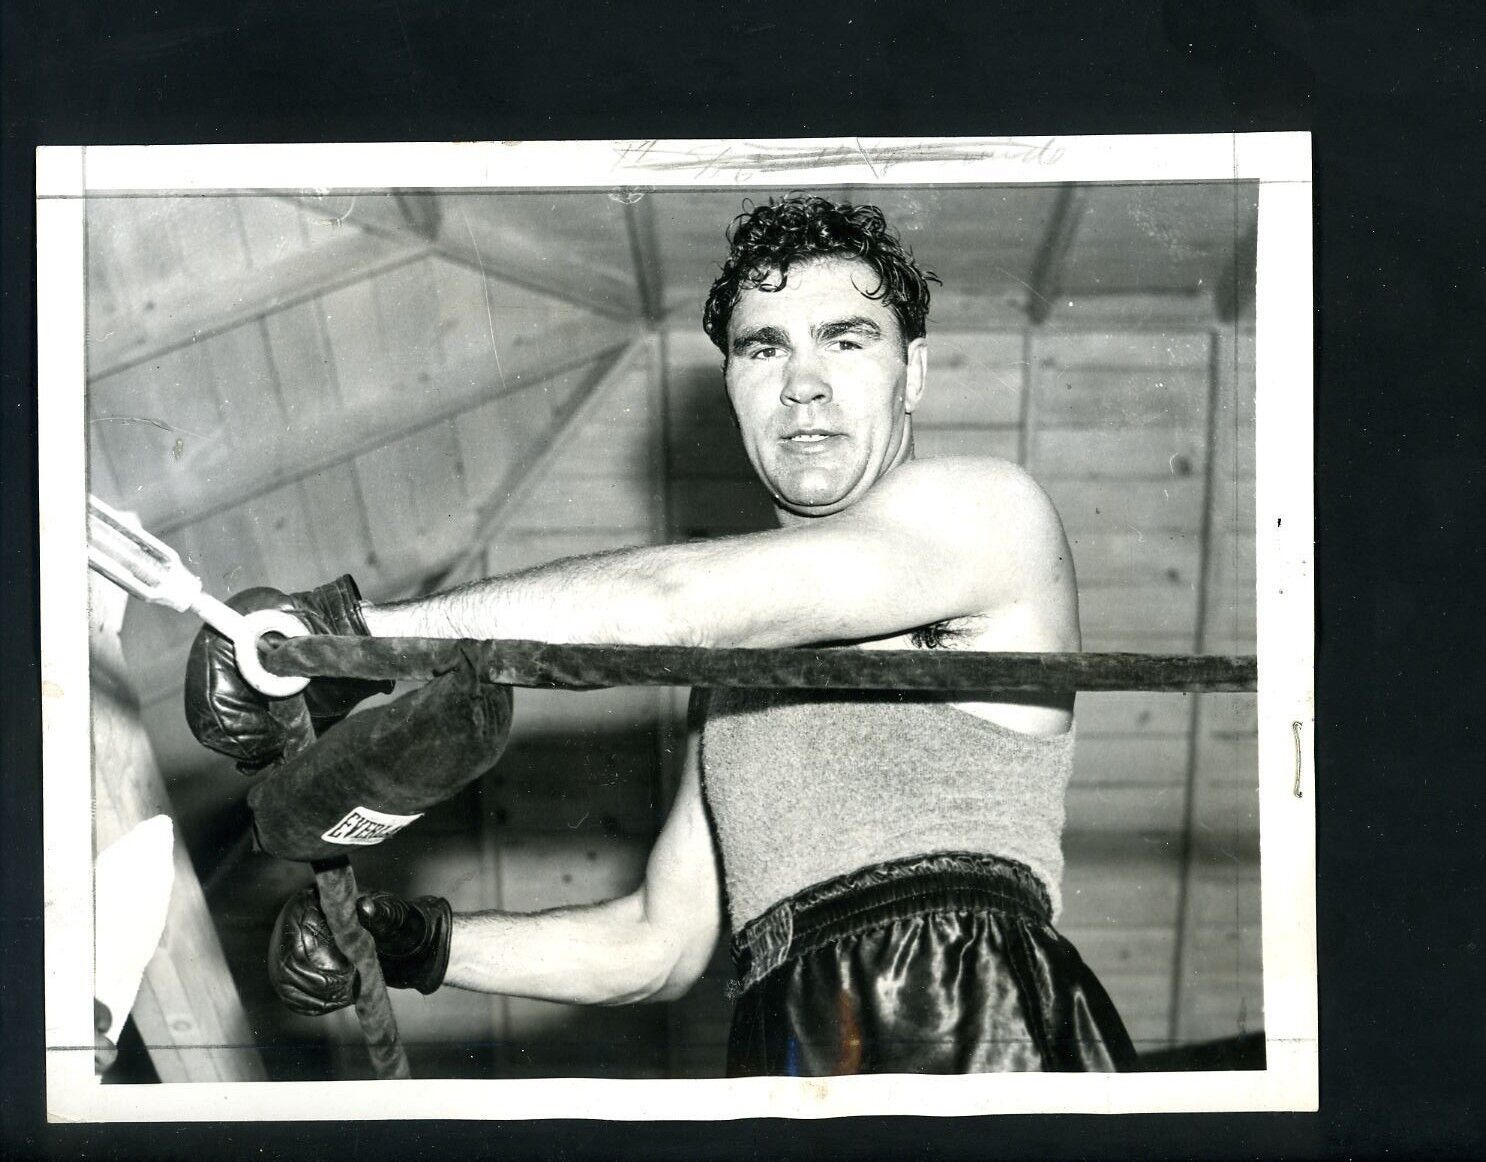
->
<box><xmin>88</xmin><ymin>230</ymin><xmax>432</xmax><ymax>382</ymax></box>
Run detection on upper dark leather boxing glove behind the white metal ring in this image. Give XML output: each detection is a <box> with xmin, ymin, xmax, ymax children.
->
<box><xmin>186</xmin><ymin>575</ymin><xmax>392</xmax><ymax>774</ymax></box>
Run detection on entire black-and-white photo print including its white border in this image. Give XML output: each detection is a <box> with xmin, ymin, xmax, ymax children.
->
<box><xmin>37</xmin><ymin>134</ymin><xmax>1317</xmax><ymax>1120</ymax></box>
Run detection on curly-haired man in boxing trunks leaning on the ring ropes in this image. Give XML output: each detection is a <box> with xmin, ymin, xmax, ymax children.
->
<box><xmin>204</xmin><ymin>196</ymin><xmax>1135</xmax><ymax>1076</ymax></box>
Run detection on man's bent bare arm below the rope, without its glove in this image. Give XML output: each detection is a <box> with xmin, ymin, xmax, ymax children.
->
<box><xmin>444</xmin><ymin>695</ymin><xmax>721</xmax><ymax>1004</ymax></box>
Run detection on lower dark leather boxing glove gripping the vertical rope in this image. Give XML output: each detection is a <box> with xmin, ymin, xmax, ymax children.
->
<box><xmin>269</xmin><ymin>887</ymin><xmax>453</xmax><ymax>1016</ymax></box>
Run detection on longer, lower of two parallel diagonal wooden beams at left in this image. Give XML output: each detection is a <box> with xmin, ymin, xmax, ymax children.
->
<box><xmin>132</xmin><ymin>319</ymin><xmax>630</xmax><ymax>536</ymax></box>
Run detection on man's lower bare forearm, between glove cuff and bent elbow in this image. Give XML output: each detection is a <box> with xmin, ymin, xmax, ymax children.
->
<box><xmin>444</xmin><ymin>896</ymin><xmax>678</xmax><ymax>1004</ymax></box>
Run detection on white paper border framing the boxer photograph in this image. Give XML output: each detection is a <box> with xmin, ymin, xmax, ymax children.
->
<box><xmin>36</xmin><ymin>132</ymin><xmax>1318</xmax><ymax>1122</ymax></box>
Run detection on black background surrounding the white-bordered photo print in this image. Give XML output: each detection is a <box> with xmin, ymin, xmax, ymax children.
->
<box><xmin>0</xmin><ymin>0</ymin><xmax>1486</xmax><ymax>1159</ymax></box>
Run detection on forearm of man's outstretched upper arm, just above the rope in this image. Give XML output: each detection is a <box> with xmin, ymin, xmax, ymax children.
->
<box><xmin>363</xmin><ymin>545</ymin><xmax>695</xmax><ymax>645</ymax></box>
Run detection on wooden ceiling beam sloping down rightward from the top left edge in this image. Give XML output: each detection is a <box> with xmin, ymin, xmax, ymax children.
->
<box><xmin>287</xmin><ymin>193</ymin><xmax>636</xmax><ymax>322</ymax></box>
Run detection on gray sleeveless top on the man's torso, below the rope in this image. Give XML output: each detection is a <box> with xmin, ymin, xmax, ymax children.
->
<box><xmin>701</xmin><ymin>689</ymin><xmax>1073</xmax><ymax>932</ymax></box>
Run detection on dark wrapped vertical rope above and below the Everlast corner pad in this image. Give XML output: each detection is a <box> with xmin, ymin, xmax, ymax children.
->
<box><xmin>269</xmin><ymin>694</ymin><xmax>413</xmax><ymax>1080</ymax></box>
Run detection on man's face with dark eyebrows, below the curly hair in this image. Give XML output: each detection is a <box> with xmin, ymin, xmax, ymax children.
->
<box><xmin>725</xmin><ymin>259</ymin><xmax>926</xmax><ymax>517</ymax></box>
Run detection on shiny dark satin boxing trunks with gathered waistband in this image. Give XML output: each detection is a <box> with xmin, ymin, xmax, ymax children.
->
<box><xmin>728</xmin><ymin>854</ymin><xmax>1137</xmax><ymax>1077</ymax></box>
